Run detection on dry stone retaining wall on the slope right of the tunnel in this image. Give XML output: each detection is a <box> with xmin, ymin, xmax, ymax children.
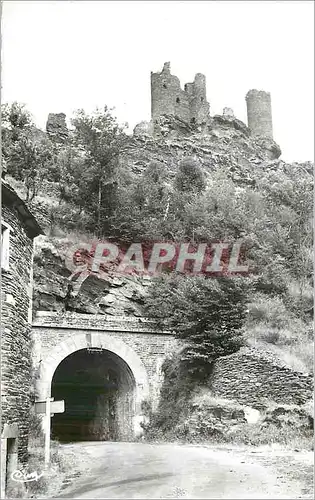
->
<box><xmin>211</xmin><ymin>348</ymin><xmax>313</xmax><ymax>410</ymax></box>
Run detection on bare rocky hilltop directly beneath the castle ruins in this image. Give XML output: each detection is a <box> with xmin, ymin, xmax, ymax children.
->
<box><xmin>123</xmin><ymin>115</ymin><xmax>281</xmax><ymax>178</ymax></box>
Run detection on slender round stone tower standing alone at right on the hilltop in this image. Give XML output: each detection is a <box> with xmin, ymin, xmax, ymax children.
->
<box><xmin>246</xmin><ymin>90</ymin><xmax>273</xmax><ymax>139</ymax></box>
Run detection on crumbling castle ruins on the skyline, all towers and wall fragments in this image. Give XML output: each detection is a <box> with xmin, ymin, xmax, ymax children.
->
<box><xmin>46</xmin><ymin>62</ymin><xmax>281</xmax><ymax>144</ymax></box>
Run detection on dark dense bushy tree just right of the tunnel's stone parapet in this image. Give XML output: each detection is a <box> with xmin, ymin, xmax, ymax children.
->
<box><xmin>146</xmin><ymin>275</ymin><xmax>249</xmax><ymax>379</ymax></box>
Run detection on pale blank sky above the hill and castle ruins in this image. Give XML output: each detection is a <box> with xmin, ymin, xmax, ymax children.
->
<box><xmin>1</xmin><ymin>0</ymin><xmax>314</xmax><ymax>161</ymax></box>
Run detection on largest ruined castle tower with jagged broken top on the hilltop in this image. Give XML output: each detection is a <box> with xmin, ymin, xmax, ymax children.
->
<box><xmin>151</xmin><ymin>62</ymin><xmax>209</xmax><ymax>124</ymax></box>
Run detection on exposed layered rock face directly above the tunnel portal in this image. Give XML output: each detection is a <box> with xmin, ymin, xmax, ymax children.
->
<box><xmin>33</xmin><ymin>237</ymin><xmax>149</xmax><ymax>316</ymax></box>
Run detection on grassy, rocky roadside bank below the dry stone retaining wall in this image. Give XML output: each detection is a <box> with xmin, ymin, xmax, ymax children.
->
<box><xmin>145</xmin><ymin>389</ymin><xmax>314</xmax><ymax>451</ymax></box>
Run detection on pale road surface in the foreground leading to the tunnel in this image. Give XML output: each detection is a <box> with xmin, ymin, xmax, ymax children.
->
<box><xmin>54</xmin><ymin>442</ymin><xmax>311</xmax><ymax>499</ymax></box>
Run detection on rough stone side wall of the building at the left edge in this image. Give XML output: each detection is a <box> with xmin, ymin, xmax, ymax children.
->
<box><xmin>1</xmin><ymin>206</ymin><xmax>33</xmax><ymax>461</ymax></box>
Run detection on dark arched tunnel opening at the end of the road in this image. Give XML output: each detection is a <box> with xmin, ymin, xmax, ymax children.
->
<box><xmin>51</xmin><ymin>348</ymin><xmax>135</xmax><ymax>442</ymax></box>
